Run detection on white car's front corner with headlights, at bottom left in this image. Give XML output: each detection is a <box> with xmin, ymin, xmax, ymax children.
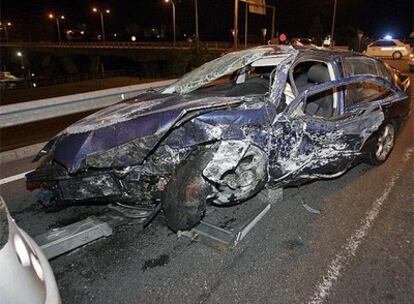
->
<box><xmin>0</xmin><ymin>196</ymin><xmax>61</xmax><ymax>304</ymax></box>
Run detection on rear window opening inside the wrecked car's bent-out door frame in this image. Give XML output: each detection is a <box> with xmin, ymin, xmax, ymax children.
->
<box><xmin>344</xmin><ymin>81</ymin><xmax>391</xmax><ymax>108</ymax></box>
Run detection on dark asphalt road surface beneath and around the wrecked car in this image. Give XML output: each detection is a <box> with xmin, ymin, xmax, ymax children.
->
<box><xmin>0</xmin><ymin>60</ymin><xmax>414</xmax><ymax>304</ymax></box>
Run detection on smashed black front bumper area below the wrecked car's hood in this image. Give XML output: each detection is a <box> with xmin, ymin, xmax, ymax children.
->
<box><xmin>26</xmin><ymin>165</ymin><xmax>165</xmax><ymax>204</ymax></box>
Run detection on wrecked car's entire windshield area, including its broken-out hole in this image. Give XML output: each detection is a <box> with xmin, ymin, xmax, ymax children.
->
<box><xmin>163</xmin><ymin>47</ymin><xmax>289</xmax><ymax>96</ymax></box>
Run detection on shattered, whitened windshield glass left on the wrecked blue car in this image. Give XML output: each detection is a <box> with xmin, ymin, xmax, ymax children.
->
<box><xmin>163</xmin><ymin>47</ymin><xmax>286</xmax><ymax>96</ymax></box>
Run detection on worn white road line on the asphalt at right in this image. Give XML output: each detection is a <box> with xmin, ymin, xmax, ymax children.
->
<box><xmin>308</xmin><ymin>148</ymin><xmax>414</xmax><ymax>304</ymax></box>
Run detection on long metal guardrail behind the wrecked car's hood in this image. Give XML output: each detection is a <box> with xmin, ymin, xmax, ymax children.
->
<box><xmin>0</xmin><ymin>79</ymin><xmax>175</xmax><ymax>128</ymax></box>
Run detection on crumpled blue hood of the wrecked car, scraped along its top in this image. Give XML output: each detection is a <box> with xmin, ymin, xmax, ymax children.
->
<box><xmin>49</xmin><ymin>93</ymin><xmax>241</xmax><ymax>173</ymax></box>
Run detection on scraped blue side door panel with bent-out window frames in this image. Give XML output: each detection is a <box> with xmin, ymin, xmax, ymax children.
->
<box><xmin>269</xmin><ymin>75</ymin><xmax>404</xmax><ymax>184</ymax></box>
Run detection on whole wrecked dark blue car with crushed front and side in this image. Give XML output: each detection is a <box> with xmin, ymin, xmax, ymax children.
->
<box><xmin>27</xmin><ymin>46</ymin><xmax>409</xmax><ymax>231</ymax></box>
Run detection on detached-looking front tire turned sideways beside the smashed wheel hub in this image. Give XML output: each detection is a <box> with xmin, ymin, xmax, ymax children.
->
<box><xmin>162</xmin><ymin>151</ymin><xmax>212</xmax><ymax>232</ymax></box>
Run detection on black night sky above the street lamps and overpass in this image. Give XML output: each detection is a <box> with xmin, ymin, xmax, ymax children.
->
<box><xmin>1</xmin><ymin>0</ymin><xmax>414</xmax><ymax>40</ymax></box>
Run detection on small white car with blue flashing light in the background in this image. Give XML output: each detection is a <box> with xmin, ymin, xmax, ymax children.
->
<box><xmin>366</xmin><ymin>39</ymin><xmax>410</xmax><ymax>59</ymax></box>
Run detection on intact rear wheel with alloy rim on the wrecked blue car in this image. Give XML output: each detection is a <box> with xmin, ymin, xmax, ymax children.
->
<box><xmin>367</xmin><ymin>122</ymin><xmax>397</xmax><ymax>166</ymax></box>
